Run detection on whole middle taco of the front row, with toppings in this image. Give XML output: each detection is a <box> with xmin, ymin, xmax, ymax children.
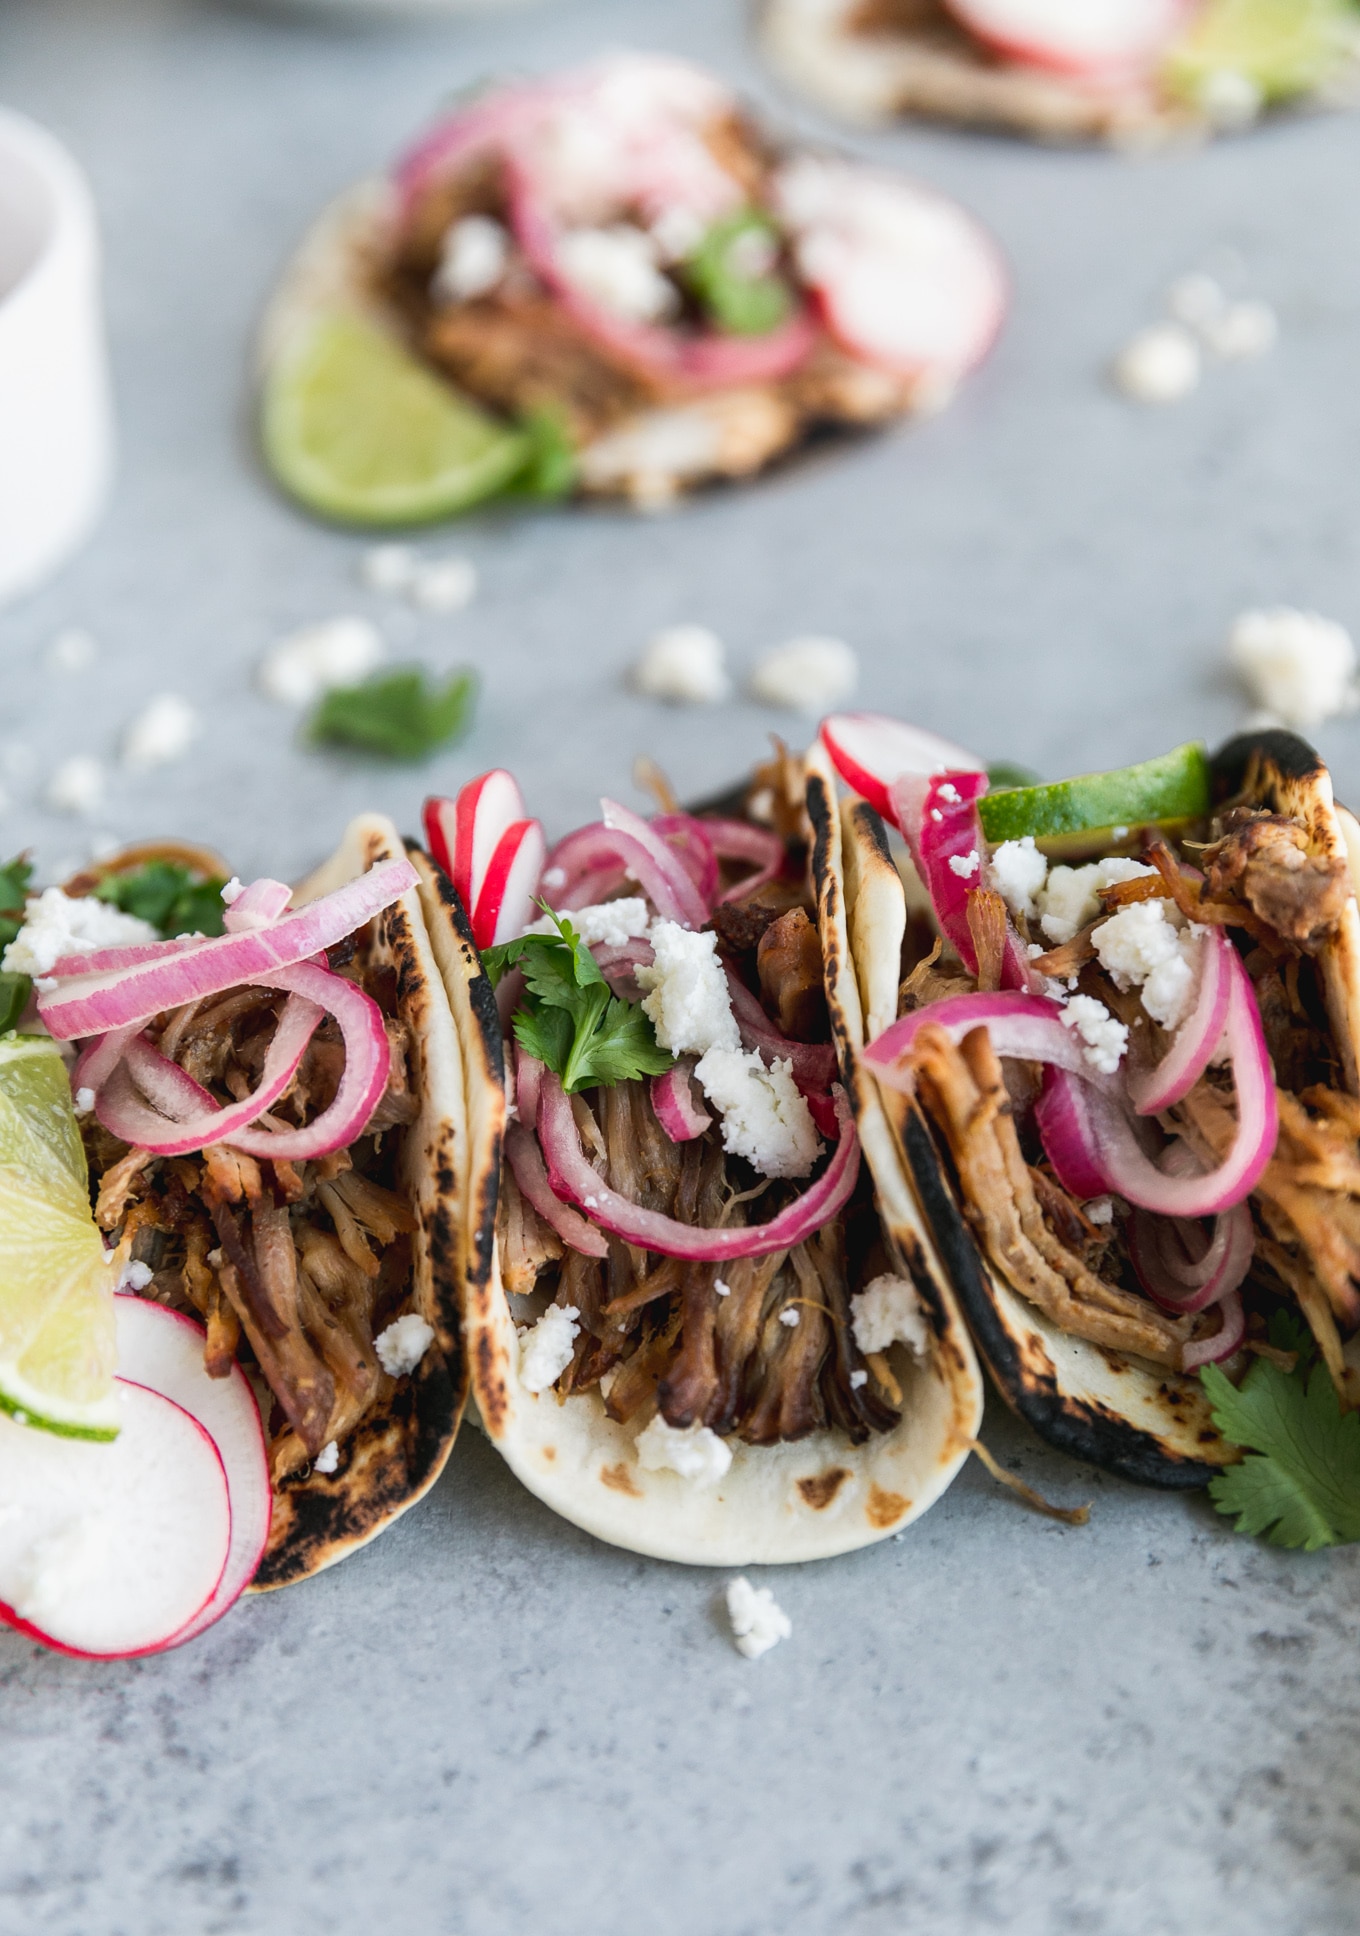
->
<box><xmin>410</xmin><ymin>753</ymin><xmax>982</xmax><ymax>1564</ymax></box>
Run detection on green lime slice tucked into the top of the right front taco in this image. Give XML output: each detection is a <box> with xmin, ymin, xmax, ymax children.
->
<box><xmin>978</xmin><ymin>741</ymin><xmax>1209</xmax><ymax>846</ymax></box>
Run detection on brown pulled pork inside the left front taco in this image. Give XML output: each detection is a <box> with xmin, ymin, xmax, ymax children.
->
<box><xmin>83</xmin><ymin>943</ymin><xmax>418</xmax><ymax>1485</ymax></box>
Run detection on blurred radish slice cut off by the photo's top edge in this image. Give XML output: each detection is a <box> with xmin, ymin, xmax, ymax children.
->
<box><xmin>947</xmin><ymin>0</ymin><xmax>1186</xmax><ymax>79</ymax></box>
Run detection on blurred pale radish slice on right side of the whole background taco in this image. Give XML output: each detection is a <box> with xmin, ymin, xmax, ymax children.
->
<box><xmin>775</xmin><ymin>155</ymin><xmax>1005</xmax><ymax>381</ymax></box>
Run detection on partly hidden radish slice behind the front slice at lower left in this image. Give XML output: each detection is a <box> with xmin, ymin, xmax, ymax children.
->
<box><xmin>114</xmin><ymin>1291</ymin><xmax>273</xmax><ymax>1646</ymax></box>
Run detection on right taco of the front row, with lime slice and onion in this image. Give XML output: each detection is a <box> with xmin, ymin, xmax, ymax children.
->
<box><xmin>823</xmin><ymin>714</ymin><xmax>1360</xmax><ymax>1487</ymax></box>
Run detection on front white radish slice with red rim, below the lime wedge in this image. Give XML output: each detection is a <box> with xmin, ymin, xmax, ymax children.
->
<box><xmin>0</xmin><ymin>1378</ymin><xmax>231</xmax><ymax>1659</ymax></box>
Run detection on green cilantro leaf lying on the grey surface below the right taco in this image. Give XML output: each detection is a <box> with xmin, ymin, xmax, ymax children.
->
<box><xmin>1201</xmin><ymin>1359</ymin><xmax>1360</xmax><ymax>1553</ymax></box>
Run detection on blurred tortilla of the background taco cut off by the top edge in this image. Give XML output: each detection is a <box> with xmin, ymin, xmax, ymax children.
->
<box><xmin>759</xmin><ymin>0</ymin><xmax>1354</xmax><ymax>149</ymax></box>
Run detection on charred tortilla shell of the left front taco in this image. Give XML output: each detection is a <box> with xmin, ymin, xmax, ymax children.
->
<box><xmin>85</xmin><ymin>815</ymin><xmax>469</xmax><ymax>1591</ymax></box>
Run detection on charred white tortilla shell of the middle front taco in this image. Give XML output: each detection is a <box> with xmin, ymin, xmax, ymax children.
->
<box><xmin>417</xmin><ymin>774</ymin><xmax>982</xmax><ymax>1566</ymax></box>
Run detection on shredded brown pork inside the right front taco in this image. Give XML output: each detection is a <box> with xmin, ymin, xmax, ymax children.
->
<box><xmin>899</xmin><ymin>782</ymin><xmax>1360</xmax><ymax>1402</ymax></box>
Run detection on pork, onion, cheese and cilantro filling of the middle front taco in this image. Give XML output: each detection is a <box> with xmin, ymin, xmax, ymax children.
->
<box><xmin>426</xmin><ymin>753</ymin><xmax>953</xmax><ymax>1504</ymax></box>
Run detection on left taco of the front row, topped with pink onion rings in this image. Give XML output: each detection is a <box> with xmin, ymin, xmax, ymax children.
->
<box><xmin>6</xmin><ymin>815</ymin><xmax>465</xmax><ymax>1610</ymax></box>
